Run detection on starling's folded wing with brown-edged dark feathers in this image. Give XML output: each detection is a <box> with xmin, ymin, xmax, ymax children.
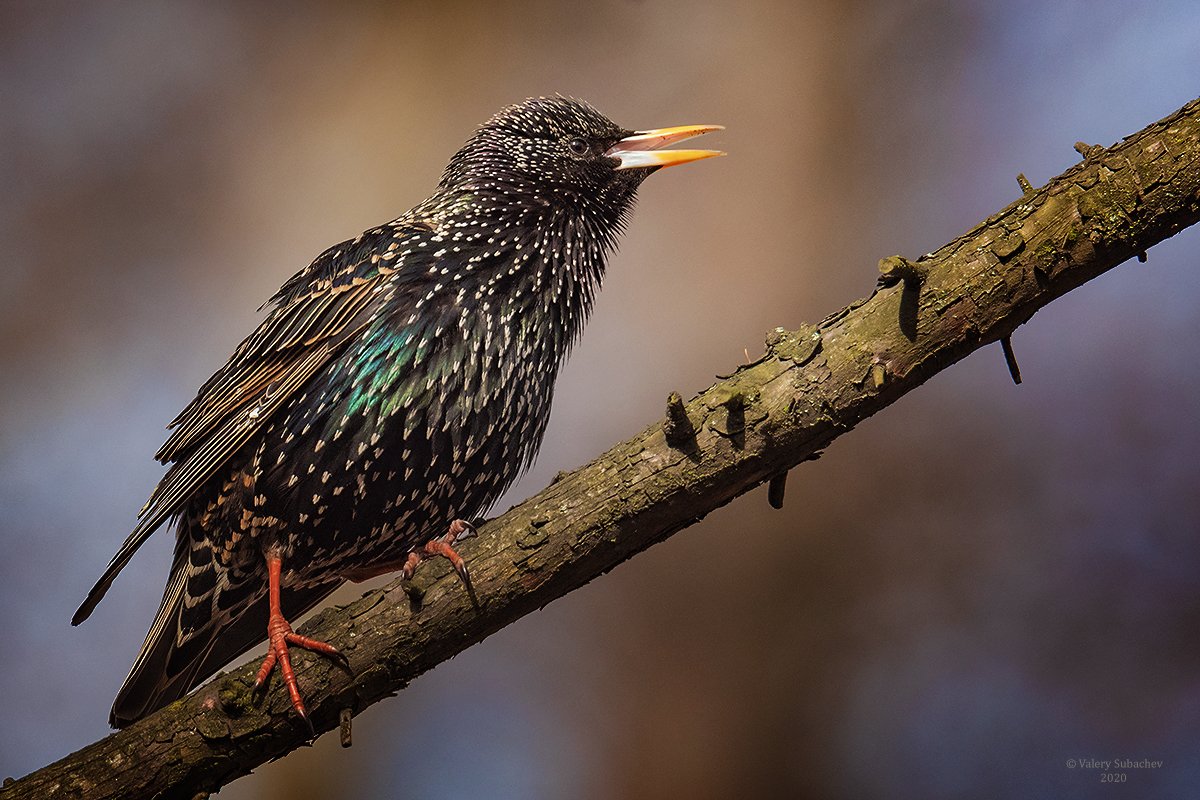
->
<box><xmin>72</xmin><ymin>223</ymin><xmax>414</xmax><ymax>625</ymax></box>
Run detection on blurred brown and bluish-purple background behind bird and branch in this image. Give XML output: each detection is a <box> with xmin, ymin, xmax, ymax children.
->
<box><xmin>0</xmin><ymin>0</ymin><xmax>1200</xmax><ymax>800</ymax></box>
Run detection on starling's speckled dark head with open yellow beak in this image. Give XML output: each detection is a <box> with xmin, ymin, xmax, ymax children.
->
<box><xmin>442</xmin><ymin>97</ymin><xmax>724</xmax><ymax>233</ymax></box>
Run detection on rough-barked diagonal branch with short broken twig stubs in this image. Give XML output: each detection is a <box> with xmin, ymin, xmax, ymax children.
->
<box><xmin>0</xmin><ymin>101</ymin><xmax>1200</xmax><ymax>800</ymax></box>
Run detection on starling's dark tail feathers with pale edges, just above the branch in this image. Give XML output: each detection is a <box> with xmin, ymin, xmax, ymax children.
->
<box><xmin>108</xmin><ymin>536</ymin><xmax>342</xmax><ymax>728</ymax></box>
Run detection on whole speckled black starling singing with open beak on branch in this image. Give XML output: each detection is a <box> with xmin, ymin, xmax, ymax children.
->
<box><xmin>72</xmin><ymin>97</ymin><xmax>721</xmax><ymax>727</ymax></box>
